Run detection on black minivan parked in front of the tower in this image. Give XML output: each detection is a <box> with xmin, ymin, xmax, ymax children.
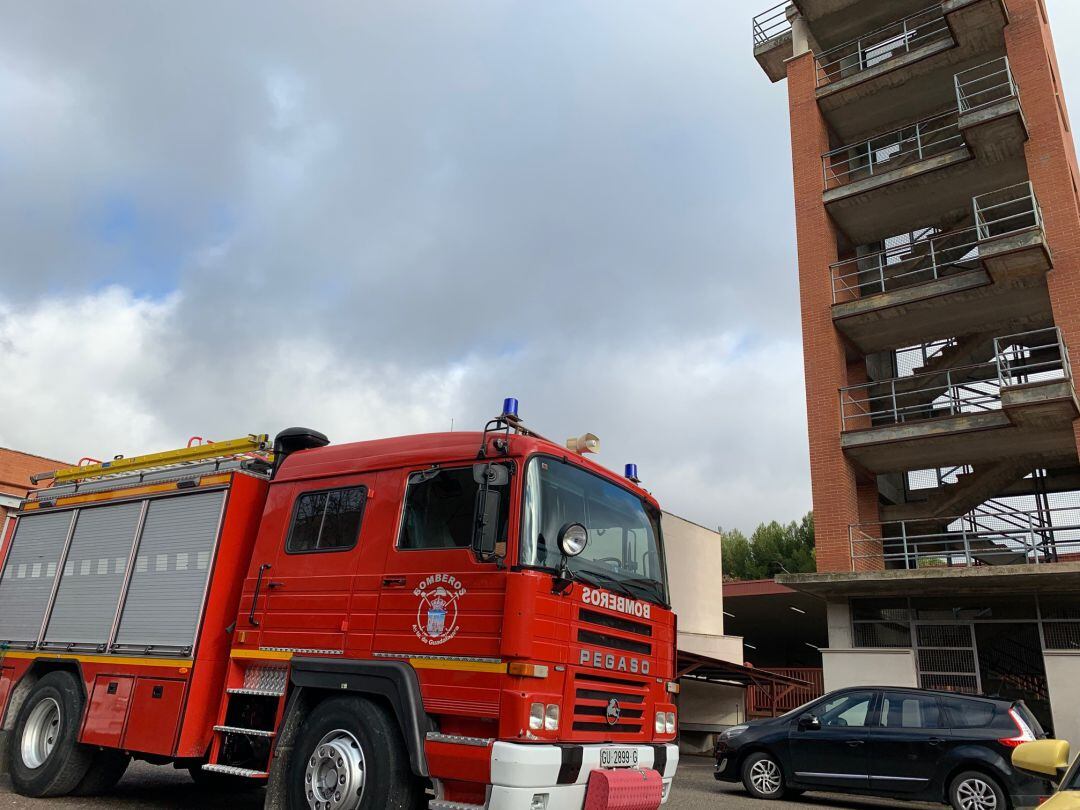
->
<box><xmin>716</xmin><ymin>687</ymin><xmax>1053</xmax><ymax>810</ymax></box>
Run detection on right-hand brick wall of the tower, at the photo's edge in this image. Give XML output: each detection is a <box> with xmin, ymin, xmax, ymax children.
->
<box><xmin>1005</xmin><ymin>0</ymin><xmax>1080</xmax><ymax>457</ymax></box>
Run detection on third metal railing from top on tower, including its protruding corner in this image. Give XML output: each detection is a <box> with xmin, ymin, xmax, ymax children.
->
<box><xmin>829</xmin><ymin>183</ymin><xmax>1042</xmax><ymax>303</ymax></box>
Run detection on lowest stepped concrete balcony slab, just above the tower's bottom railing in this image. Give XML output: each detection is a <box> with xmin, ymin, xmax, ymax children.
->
<box><xmin>840</xmin><ymin>380</ymin><xmax>1080</xmax><ymax>474</ymax></box>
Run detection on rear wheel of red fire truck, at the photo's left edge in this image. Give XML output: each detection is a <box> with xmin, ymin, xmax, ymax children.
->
<box><xmin>10</xmin><ymin>672</ymin><xmax>94</xmax><ymax>797</ymax></box>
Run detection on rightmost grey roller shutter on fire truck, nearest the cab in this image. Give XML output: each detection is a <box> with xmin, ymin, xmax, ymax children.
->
<box><xmin>116</xmin><ymin>491</ymin><xmax>226</xmax><ymax>649</ymax></box>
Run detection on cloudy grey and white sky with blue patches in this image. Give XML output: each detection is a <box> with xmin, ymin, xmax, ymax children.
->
<box><xmin>0</xmin><ymin>0</ymin><xmax>1080</xmax><ymax>529</ymax></box>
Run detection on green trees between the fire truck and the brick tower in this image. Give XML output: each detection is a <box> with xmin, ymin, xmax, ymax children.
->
<box><xmin>720</xmin><ymin>512</ymin><xmax>816</xmax><ymax>579</ymax></box>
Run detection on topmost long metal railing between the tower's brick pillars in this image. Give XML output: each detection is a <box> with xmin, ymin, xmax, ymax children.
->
<box><xmin>815</xmin><ymin>3</ymin><xmax>953</xmax><ymax>87</ymax></box>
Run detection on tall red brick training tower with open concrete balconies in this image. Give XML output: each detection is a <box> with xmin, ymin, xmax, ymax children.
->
<box><xmin>753</xmin><ymin>0</ymin><xmax>1080</xmax><ymax>739</ymax></box>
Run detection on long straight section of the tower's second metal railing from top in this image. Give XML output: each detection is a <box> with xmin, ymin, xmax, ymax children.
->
<box><xmin>821</xmin><ymin>110</ymin><xmax>964</xmax><ymax>191</ymax></box>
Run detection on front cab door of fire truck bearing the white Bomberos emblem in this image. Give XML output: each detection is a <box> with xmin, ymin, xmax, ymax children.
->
<box><xmin>375</xmin><ymin>463</ymin><xmax>511</xmax><ymax>663</ymax></box>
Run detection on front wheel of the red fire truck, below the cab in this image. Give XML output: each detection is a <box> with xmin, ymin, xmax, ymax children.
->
<box><xmin>286</xmin><ymin>697</ymin><xmax>423</xmax><ymax>810</ymax></box>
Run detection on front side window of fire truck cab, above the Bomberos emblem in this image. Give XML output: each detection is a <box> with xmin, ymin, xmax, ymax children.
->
<box><xmin>397</xmin><ymin>467</ymin><xmax>510</xmax><ymax>551</ymax></box>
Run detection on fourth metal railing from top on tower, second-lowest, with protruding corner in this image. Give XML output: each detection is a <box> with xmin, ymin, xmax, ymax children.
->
<box><xmin>840</xmin><ymin>327</ymin><xmax>1072</xmax><ymax>431</ymax></box>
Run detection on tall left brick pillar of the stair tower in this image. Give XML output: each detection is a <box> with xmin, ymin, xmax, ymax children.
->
<box><xmin>787</xmin><ymin>53</ymin><xmax>877</xmax><ymax>571</ymax></box>
